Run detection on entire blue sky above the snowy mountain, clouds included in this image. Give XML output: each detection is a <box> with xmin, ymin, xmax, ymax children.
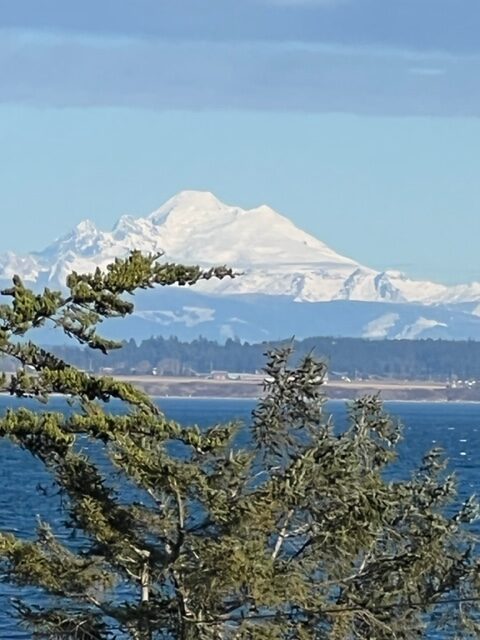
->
<box><xmin>0</xmin><ymin>0</ymin><xmax>480</xmax><ymax>282</ymax></box>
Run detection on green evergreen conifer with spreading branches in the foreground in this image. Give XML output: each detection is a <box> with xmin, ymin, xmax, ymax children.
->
<box><xmin>0</xmin><ymin>253</ymin><xmax>480</xmax><ymax>640</ymax></box>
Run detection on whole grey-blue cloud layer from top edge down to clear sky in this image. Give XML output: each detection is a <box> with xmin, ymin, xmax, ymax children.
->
<box><xmin>0</xmin><ymin>0</ymin><xmax>480</xmax><ymax>116</ymax></box>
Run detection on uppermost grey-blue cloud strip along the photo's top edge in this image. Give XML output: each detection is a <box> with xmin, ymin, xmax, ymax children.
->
<box><xmin>0</xmin><ymin>0</ymin><xmax>480</xmax><ymax>54</ymax></box>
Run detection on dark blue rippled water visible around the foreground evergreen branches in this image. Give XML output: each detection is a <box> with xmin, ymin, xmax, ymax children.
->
<box><xmin>0</xmin><ymin>397</ymin><xmax>480</xmax><ymax>640</ymax></box>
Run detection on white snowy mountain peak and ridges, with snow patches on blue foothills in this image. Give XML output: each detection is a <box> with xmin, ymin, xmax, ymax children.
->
<box><xmin>0</xmin><ymin>191</ymin><xmax>480</xmax><ymax>337</ymax></box>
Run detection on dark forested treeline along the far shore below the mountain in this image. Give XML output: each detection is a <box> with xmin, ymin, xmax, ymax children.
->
<box><xmin>16</xmin><ymin>337</ymin><xmax>480</xmax><ymax>379</ymax></box>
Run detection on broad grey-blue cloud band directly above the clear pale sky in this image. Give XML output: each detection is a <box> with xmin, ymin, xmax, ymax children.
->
<box><xmin>0</xmin><ymin>34</ymin><xmax>480</xmax><ymax>116</ymax></box>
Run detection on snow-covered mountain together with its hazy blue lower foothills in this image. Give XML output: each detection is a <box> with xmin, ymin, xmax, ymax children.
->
<box><xmin>0</xmin><ymin>191</ymin><xmax>480</xmax><ymax>339</ymax></box>
